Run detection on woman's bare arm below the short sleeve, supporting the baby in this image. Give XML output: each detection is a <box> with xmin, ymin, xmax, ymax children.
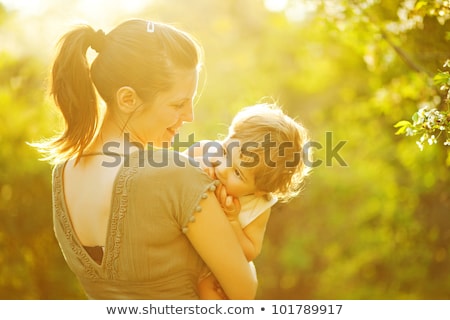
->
<box><xmin>186</xmin><ymin>192</ymin><xmax>258</xmax><ymax>300</ymax></box>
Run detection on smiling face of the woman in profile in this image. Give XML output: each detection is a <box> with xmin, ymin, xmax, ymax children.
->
<box><xmin>129</xmin><ymin>70</ymin><xmax>198</xmax><ymax>147</ymax></box>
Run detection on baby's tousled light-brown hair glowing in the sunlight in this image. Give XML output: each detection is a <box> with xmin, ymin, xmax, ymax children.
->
<box><xmin>226</xmin><ymin>103</ymin><xmax>310</xmax><ymax>202</ymax></box>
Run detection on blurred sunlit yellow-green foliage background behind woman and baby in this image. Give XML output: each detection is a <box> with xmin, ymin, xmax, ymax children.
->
<box><xmin>0</xmin><ymin>0</ymin><xmax>450</xmax><ymax>299</ymax></box>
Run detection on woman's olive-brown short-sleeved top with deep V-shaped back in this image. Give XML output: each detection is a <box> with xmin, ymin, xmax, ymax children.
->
<box><xmin>53</xmin><ymin>149</ymin><xmax>215</xmax><ymax>300</ymax></box>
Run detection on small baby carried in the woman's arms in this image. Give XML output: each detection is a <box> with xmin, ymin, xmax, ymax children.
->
<box><xmin>186</xmin><ymin>104</ymin><xmax>310</xmax><ymax>299</ymax></box>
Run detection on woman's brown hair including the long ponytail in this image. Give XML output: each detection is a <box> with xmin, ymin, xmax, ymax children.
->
<box><xmin>33</xmin><ymin>19</ymin><xmax>203</xmax><ymax>163</ymax></box>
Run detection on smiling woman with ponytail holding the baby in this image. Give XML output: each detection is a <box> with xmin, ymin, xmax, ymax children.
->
<box><xmin>36</xmin><ymin>19</ymin><xmax>257</xmax><ymax>299</ymax></box>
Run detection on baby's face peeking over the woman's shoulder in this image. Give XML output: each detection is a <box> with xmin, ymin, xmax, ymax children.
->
<box><xmin>215</xmin><ymin>141</ymin><xmax>257</xmax><ymax>197</ymax></box>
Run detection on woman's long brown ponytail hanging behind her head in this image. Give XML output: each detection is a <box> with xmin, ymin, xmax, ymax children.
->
<box><xmin>41</xmin><ymin>26</ymin><xmax>100</xmax><ymax>162</ymax></box>
